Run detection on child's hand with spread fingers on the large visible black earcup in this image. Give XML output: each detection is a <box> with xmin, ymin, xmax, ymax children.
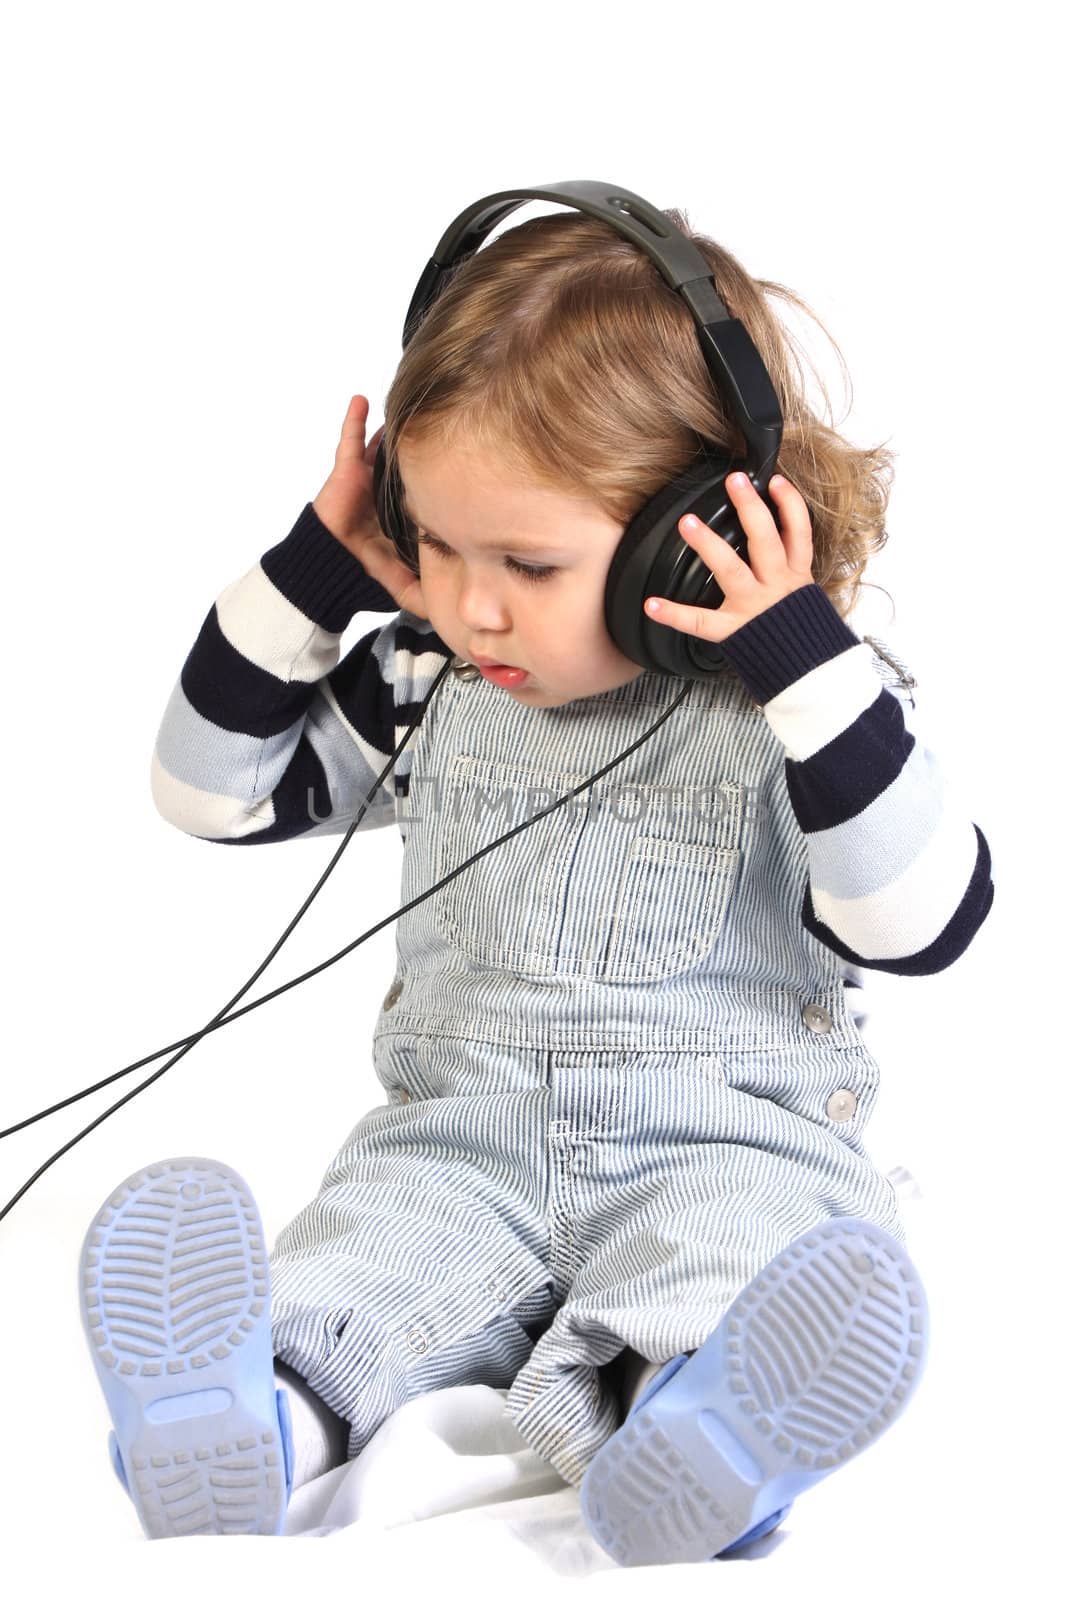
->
<box><xmin>645</xmin><ymin>472</ymin><xmax>814</xmax><ymax>645</ymax></box>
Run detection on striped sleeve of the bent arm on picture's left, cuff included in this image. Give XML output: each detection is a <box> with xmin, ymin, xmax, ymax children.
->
<box><xmin>150</xmin><ymin>502</ymin><xmax>450</xmax><ymax>845</ymax></box>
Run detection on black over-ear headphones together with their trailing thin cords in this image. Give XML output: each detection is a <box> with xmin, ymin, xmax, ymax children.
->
<box><xmin>0</xmin><ymin>181</ymin><xmax>793</xmax><ymax>1221</ymax></box>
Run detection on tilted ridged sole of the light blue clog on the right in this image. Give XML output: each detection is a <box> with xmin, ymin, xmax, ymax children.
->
<box><xmin>579</xmin><ymin>1218</ymin><xmax>928</xmax><ymax>1566</ymax></box>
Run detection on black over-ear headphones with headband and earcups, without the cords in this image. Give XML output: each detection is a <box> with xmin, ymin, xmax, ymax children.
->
<box><xmin>374</xmin><ymin>179</ymin><xmax>782</xmax><ymax>678</ymax></box>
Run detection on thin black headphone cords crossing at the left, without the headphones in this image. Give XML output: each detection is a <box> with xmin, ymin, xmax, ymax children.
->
<box><xmin>0</xmin><ymin>658</ymin><xmax>696</xmax><ymax>1222</ymax></box>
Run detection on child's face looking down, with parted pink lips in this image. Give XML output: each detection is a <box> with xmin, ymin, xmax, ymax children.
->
<box><xmin>398</xmin><ymin>443</ymin><xmax>645</xmax><ymax>706</ymax></box>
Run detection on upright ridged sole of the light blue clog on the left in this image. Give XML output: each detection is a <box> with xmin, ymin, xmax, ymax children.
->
<box><xmin>78</xmin><ymin>1157</ymin><xmax>288</xmax><ymax>1539</ymax></box>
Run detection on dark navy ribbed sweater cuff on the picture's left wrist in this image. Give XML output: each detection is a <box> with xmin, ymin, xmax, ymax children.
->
<box><xmin>259</xmin><ymin>501</ymin><xmax>400</xmax><ymax>634</ymax></box>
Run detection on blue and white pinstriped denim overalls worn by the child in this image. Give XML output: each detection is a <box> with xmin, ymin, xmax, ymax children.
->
<box><xmin>270</xmin><ymin>646</ymin><xmax>905</xmax><ymax>1485</ymax></box>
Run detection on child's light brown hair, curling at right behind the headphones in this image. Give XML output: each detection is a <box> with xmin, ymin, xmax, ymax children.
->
<box><xmin>384</xmin><ymin>210</ymin><xmax>896</xmax><ymax>630</ymax></box>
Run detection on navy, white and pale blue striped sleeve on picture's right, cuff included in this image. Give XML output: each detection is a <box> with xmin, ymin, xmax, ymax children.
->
<box><xmin>721</xmin><ymin>582</ymin><xmax>993</xmax><ymax>976</ymax></box>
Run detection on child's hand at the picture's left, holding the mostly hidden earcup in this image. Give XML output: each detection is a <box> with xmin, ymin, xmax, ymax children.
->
<box><xmin>312</xmin><ymin>395</ymin><xmax>429</xmax><ymax>621</ymax></box>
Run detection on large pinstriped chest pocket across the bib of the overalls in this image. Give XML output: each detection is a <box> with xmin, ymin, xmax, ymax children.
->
<box><xmin>434</xmin><ymin>755</ymin><xmax>750</xmax><ymax>982</ymax></box>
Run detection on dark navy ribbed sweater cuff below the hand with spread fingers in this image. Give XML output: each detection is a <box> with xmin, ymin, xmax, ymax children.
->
<box><xmin>718</xmin><ymin>582</ymin><xmax>861</xmax><ymax>706</ymax></box>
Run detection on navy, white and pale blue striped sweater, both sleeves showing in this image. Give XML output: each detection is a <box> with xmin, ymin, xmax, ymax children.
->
<box><xmin>152</xmin><ymin>502</ymin><xmax>993</xmax><ymax>985</ymax></box>
